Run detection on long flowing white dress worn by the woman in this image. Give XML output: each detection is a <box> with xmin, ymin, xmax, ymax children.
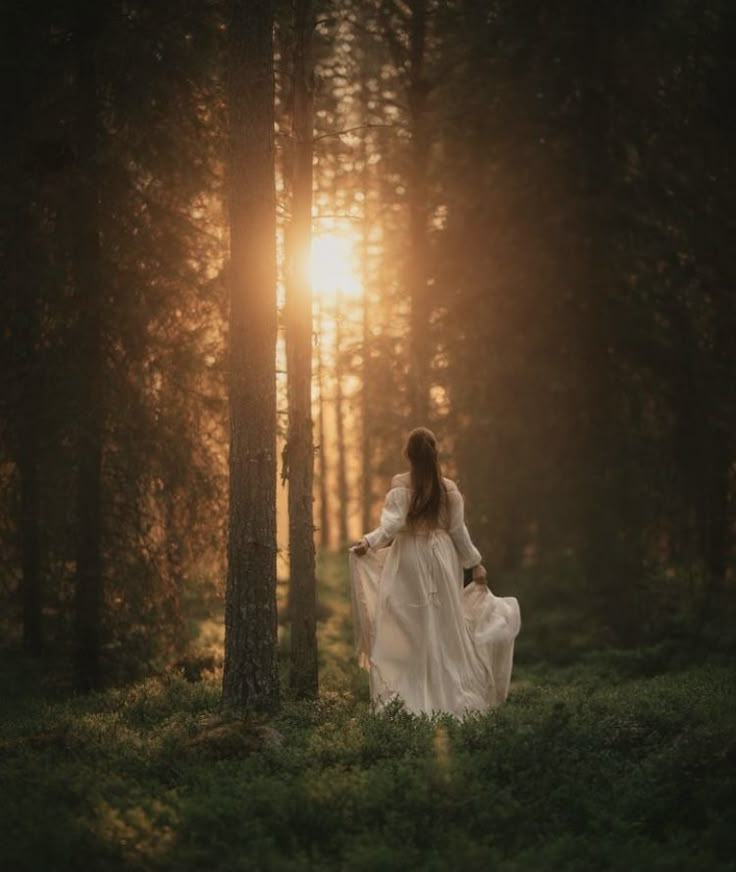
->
<box><xmin>350</xmin><ymin>474</ymin><xmax>521</xmax><ymax>717</ymax></box>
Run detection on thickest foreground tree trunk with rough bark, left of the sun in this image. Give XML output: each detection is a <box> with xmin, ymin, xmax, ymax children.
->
<box><xmin>223</xmin><ymin>0</ymin><xmax>279</xmax><ymax>710</ymax></box>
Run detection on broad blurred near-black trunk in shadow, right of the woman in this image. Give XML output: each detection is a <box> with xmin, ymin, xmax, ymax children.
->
<box><xmin>571</xmin><ymin>4</ymin><xmax>641</xmax><ymax>642</ymax></box>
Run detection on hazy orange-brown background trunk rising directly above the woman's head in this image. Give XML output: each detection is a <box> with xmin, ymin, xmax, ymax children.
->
<box><xmin>407</xmin><ymin>0</ymin><xmax>431</xmax><ymax>425</ymax></box>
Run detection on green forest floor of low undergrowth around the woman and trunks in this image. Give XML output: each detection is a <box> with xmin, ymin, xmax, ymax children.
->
<box><xmin>0</xmin><ymin>557</ymin><xmax>736</xmax><ymax>872</ymax></box>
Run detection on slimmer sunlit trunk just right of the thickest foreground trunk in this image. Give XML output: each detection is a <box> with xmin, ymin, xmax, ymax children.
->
<box><xmin>285</xmin><ymin>0</ymin><xmax>318</xmax><ymax>697</ymax></box>
